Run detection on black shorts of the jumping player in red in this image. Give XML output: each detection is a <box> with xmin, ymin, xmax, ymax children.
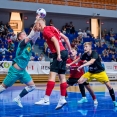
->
<box><xmin>50</xmin><ymin>50</ymin><xmax>68</xmax><ymax>74</ymax></box>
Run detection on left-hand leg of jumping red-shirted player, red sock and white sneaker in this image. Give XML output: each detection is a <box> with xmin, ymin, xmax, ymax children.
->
<box><xmin>35</xmin><ymin>72</ymin><xmax>57</xmax><ymax>105</ymax></box>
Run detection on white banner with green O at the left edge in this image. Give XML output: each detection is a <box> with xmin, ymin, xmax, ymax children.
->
<box><xmin>0</xmin><ymin>61</ymin><xmax>12</xmax><ymax>74</ymax></box>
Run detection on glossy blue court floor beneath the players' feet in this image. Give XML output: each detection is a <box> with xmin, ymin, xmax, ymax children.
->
<box><xmin>0</xmin><ymin>84</ymin><xmax>117</xmax><ymax>117</ymax></box>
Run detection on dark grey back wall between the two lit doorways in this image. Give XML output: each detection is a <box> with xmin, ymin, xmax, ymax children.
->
<box><xmin>24</xmin><ymin>13</ymin><xmax>89</xmax><ymax>30</ymax></box>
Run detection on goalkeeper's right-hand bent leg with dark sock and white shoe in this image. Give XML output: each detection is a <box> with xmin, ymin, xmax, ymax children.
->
<box><xmin>13</xmin><ymin>71</ymin><xmax>35</xmax><ymax>107</ymax></box>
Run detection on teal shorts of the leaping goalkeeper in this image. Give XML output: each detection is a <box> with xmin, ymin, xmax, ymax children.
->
<box><xmin>3</xmin><ymin>66</ymin><xmax>32</xmax><ymax>87</ymax></box>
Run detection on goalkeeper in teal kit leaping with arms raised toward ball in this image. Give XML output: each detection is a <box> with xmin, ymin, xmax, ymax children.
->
<box><xmin>0</xmin><ymin>29</ymin><xmax>39</xmax><ymax>107</ymax></box>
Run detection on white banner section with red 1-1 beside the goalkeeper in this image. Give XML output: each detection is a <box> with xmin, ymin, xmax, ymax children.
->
<box><xmin>26</xmin><ymin>61</ymin><xmax>39</xmax><ymax>74</ymax></box>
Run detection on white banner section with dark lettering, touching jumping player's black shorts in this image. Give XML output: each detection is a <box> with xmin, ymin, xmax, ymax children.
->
<box><xmin>38</xmin><ymin>61</ymin><xmax>50</xmax><ymax>74</ymax></box>
